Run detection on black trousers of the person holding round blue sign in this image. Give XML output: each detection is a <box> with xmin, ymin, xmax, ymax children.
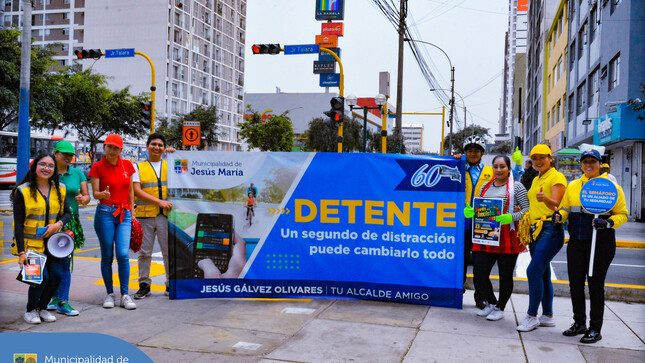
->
<box><xmin>567</xmin><ymin>237</ymin><xmax>616</xmax><ymax>332</ymax></box>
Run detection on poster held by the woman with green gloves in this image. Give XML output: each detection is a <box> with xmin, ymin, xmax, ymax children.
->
<box><xmin>473</xmin><ymin>197</ymin><xmax>504</xmax><ymax>246</ymax></box>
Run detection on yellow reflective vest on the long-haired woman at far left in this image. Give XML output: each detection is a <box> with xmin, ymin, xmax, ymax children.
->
<box><xmin>18</xmin><ymin>183</ymin><xmax>67</xmax><ymax>253</ymax></box>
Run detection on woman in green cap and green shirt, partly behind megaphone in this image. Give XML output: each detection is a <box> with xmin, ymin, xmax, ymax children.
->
<box><xmin>47</xmin><ymin>140</ymin><xmax>90</xmax><ymax>316</ymax></box>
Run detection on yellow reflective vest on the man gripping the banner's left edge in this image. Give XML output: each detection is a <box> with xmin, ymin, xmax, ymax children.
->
<box><xmin>134</xmin><ymin>160</ymin><xmax>168</xmax><ymax>218</ymax></box>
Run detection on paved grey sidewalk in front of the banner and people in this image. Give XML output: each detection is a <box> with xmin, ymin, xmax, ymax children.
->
<box><xmin>0</xmin><ymin>257</ymin><xmax>645</xmax><ymax>363</ymax></box>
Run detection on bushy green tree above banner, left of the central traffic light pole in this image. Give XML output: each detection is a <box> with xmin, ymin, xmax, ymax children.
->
<box><xmin>238</xmin><ymin>106</ymin><xmax>294</xmax><ymax>151</ymax></box>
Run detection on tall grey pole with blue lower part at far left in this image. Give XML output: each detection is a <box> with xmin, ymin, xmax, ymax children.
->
<box><xmin>16</xmin><ymin>0</ymin><xmax>31</xmax><ymax>185</ymax></box>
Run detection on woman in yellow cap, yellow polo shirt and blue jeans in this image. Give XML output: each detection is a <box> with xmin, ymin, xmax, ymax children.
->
<box><xmin>517</xmin><ymin>144</ymin><xmax>567</xmax><ymax>332</ymax></box>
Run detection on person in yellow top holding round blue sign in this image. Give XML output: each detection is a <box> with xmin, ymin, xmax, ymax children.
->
<box><xmin>553</xmin><ymin>150</ymin><xmax>629</xmax><ymax>343</ymax></box>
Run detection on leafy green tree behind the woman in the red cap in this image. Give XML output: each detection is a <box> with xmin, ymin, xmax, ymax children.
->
<box><xmin>34</xmin><ymin>70</ymin><xmax>148</xmax><ymax>161</ymax></box>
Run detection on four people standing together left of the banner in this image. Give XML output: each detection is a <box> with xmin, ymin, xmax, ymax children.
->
<box><xmin>11</xmin><ymin>133</ymin><xmax>174</xmax><ymax>324</ymax></box>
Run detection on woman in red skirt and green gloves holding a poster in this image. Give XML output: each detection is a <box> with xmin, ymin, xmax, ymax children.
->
<box><xmin>464</xmin><ymin>155</ymin><xmax>529</xmax><ymax>320</ymax></box>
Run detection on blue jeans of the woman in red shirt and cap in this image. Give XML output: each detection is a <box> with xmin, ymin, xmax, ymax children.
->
<box><xmin>94</xmin><ymin>204</ymin><xmax>132</xmax><ymax>295</ymax></box>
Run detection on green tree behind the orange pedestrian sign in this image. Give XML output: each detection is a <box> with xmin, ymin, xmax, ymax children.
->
<box><xmin>155</xmin><ymin>106</ymin><xmax>219</xmax><ymax>150</ymax></box>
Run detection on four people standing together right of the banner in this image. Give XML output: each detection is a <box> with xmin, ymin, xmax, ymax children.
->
<box><xmin>464</xmin><ymin>136</ymin><xmax>628</xmax><ymax>343</ymax></box>
